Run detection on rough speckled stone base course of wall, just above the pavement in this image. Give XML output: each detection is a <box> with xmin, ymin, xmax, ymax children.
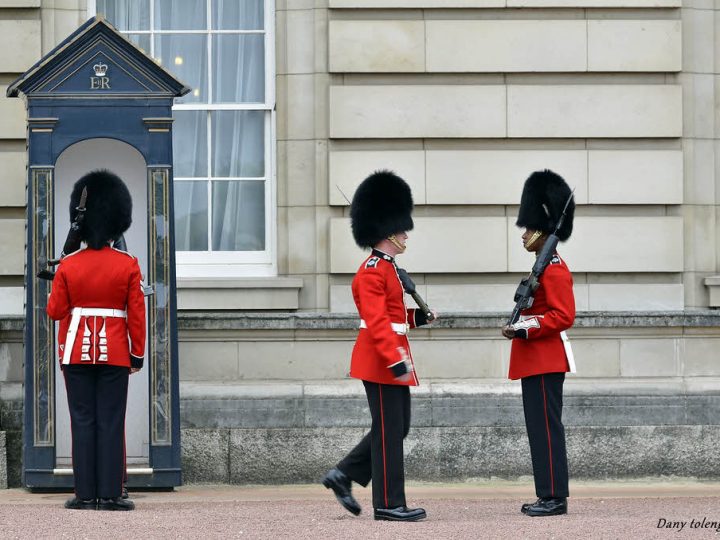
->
<box><xmin>182</xmin><ymin>426</ymin><xmax>720</xmax><ymax>484</ymax></box>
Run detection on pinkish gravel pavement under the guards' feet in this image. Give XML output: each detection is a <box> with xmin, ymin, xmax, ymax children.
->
<box><xmin>0</xmin><ymin>481</ymin><xmax>720</xmax><ymax>540</ymax></box>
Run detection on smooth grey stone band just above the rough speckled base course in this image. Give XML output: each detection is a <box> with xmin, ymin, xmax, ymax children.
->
<box><xmin>180</xmin><ymin>378</ymin><xmax>720</xmax><ymax>429</ymax></box>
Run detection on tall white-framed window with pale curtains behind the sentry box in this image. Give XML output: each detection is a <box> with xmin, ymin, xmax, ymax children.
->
<box><xmin>89</xmin><ymin>0</ymin><xmax>276</xmax><ymax>277</ymax></box>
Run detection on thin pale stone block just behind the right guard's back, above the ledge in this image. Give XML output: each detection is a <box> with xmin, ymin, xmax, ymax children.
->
<box><xmin>587</xmin><ymin>283</ymin><xmax>685</xmax><ymax>311</ymax></box>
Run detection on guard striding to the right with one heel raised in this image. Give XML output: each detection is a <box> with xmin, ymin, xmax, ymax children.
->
<box><xmin>322</xmin><ymin>171</ymin><xmax>436</xmax><ymax>521</ymax></box>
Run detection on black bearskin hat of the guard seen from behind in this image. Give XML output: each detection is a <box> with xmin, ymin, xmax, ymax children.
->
<box><xmin>70</xmin><ymin>169</ymin><xmax>132</xmax><ymax>249</ymax></box>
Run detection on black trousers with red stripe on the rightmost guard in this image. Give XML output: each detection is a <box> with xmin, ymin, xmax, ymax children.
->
<box><xmin>522</xmin><ymin>373</ymin><xmax>568</xmax><ymax>497</ymax></box>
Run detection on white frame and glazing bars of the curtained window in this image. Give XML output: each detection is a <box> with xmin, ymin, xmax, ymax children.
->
<box><xmin>87</xmin><ymin>0</ymin><xmax>277</xmax><ymax>278</ymax></box>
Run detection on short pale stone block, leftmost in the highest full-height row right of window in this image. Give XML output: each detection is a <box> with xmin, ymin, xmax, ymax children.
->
<box><xmin>328</xmin><ymin>20</ymin><xmax>425</xmax><ymax>73</ymax></box>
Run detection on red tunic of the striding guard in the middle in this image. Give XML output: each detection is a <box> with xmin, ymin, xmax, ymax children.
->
<box><xmin>350</xmin><ymin>250</ymin><xmax>418</xmax><ymax>386</ymax></box>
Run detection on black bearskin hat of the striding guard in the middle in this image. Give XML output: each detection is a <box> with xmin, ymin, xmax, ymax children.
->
<box><xmin>350</xmin><ymin>170</ymin><xmax>413</xmax><ymax>248</ymax></box>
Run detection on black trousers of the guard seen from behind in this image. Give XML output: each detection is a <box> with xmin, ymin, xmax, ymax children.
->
<box><xmin>63</xmin><ymin>364</ymin><xmax>130</xmax><ymax>499</ymax></box>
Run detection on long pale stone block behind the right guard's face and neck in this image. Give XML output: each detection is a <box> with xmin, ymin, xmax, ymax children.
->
<box><xmin>508</xmin><ymin>216</ymin><xmax>684</xmax><ymax>272</ymax></box>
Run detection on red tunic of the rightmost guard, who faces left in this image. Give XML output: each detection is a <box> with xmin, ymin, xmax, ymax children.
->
<box><xmin>508</xmin><ymin>254</ymin><xmax>575</xmax><ymax>379</ymax></box>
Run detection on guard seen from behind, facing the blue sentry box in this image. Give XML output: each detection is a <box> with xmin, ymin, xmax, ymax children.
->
<box><xmin>47</xmin><ymin>170</ymin><xmax>146</xmax><ymax>510</ymax></box>
